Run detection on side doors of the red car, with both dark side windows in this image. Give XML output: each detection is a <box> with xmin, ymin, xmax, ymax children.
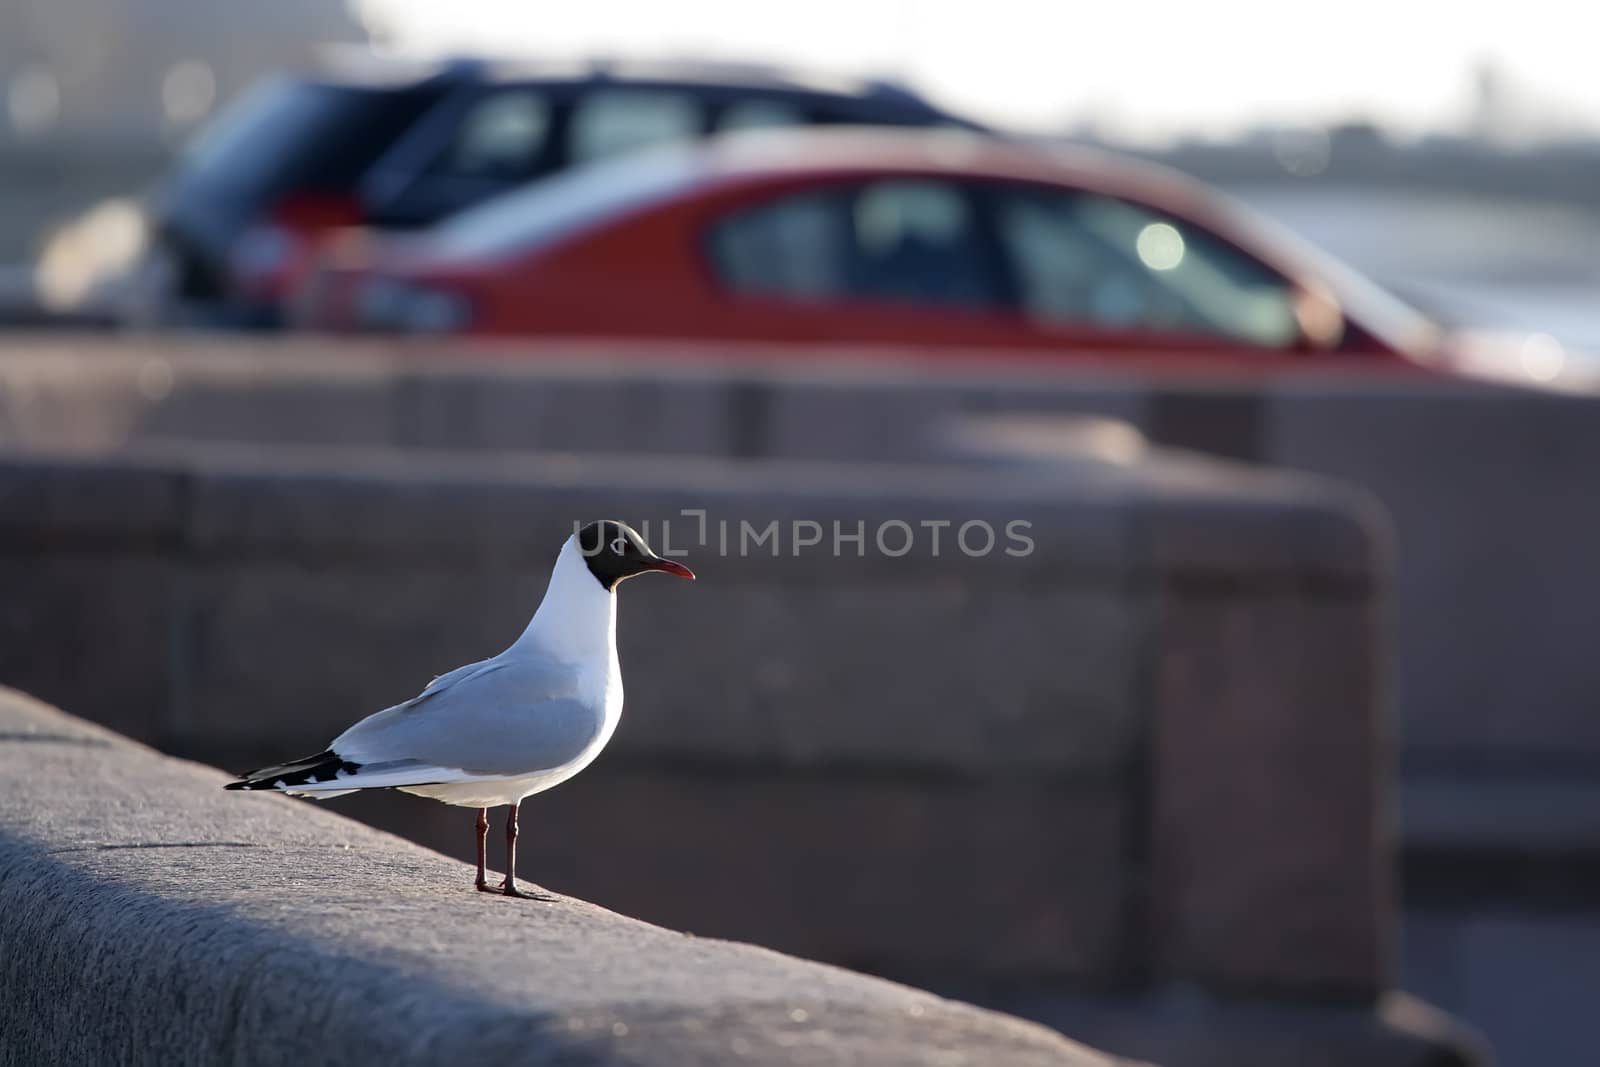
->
<box><xmin>706</xmin><ymin>176</ymin><xmax>1302</xmax><ymax>363</ymax></box>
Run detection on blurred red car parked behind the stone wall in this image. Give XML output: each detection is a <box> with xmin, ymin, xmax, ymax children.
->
<box><xmin>293</xmin><ymin>130</ymin><xmax>1438</xmax><ymax>365</ymax></box>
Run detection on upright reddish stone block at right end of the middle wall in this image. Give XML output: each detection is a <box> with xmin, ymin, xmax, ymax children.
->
<box><xmin>1150</xmin><ymin>585</ymin><xmax>1394</xmax><ymax>997</ymax></box>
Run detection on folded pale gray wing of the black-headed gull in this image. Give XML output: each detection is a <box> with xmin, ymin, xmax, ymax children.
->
<box><xmin>330</xmin><ymin>659</ymin><xmax>603</xmax><ymax>777</ymax></box>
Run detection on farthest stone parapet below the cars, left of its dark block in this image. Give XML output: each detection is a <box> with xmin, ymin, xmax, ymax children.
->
<box><xmin>0</xmin><ymin>338</ymin><xmax>1149</xmax><ymax>461</ymax></box>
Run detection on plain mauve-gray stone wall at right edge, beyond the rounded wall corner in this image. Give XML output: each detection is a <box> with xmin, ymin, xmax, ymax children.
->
<box><xmin>1264</xmin><ymin>381</ymin><xmax>1600</xmax><ymax>768</ymax></box>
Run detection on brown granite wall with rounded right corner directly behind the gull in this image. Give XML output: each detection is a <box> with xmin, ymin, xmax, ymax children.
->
<box><xmin>0</xmin><ymin>357</ymin><xmax>1470</xmax><ymax>1067</ymax></box>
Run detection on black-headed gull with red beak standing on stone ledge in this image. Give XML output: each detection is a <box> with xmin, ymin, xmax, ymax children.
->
<box><xmin>224</xmin><ymin>520</ymin><xmax>694</xmax><ymax>897</ymax></box>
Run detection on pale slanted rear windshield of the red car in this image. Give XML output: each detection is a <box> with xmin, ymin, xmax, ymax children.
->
<box><xmin>427</xmin><ymin>149</ymin><xmax>699</xmax><ymax>259</ymax></box>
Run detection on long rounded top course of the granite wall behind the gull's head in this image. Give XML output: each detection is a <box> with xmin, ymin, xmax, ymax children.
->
<box><xmin>0</xmin><ymin>431</ymin><xmax>1384</xmax><ymax>589</ymax></box>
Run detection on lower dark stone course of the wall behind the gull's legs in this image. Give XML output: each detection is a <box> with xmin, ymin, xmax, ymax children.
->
<box><xmin>330</xmin><ymin>767</ymin><xmax>1134</xmax><ymax>985</ymax></box>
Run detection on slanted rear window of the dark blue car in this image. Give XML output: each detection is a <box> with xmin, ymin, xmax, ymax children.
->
<box><xmin>181</xmin><ymin>78</ymin><xmax>438</xmax><ymax>192</ymax></box>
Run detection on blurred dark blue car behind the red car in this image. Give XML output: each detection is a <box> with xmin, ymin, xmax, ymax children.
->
<box><xmin>149</xmin><ymin>61</ymin><xmax>979</xmax><ymax>325</ymax></box>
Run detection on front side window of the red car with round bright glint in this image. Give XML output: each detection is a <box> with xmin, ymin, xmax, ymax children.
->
<box><xmin>995</xmin><ymin>189</ymin><xmax>1299</xmax><ymax>347</ymax></box>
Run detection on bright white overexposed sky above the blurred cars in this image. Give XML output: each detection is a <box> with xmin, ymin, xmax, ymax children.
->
<box><xmin>350</xmin><ymin>0</ymin><xmax>1600</xmax><ymax>139</ymax></box>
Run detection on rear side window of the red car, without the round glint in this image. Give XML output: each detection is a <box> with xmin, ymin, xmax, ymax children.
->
<box><xmin>710</xmin><ymin>179</ymin><xmax>1000</xmax><ymax>307</ymax></box>
